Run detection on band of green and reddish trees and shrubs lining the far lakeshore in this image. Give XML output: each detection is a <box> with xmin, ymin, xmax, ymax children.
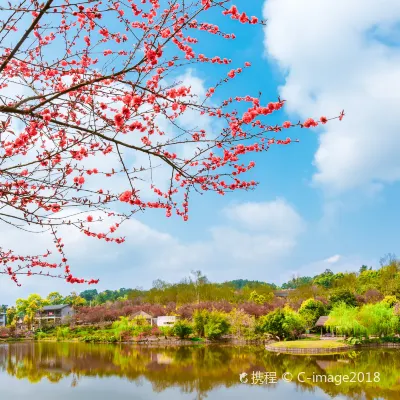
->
<box><xmin>0</xmin><ymin>255</ymin><xmax>400</xmax><ymax>344</ymax></box>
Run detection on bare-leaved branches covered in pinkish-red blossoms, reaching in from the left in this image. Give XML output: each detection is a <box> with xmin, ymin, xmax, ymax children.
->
<box><xmin>0</xmin><ymin>0</ymin><xmax>344</xmax><ymax>285</ymax></box>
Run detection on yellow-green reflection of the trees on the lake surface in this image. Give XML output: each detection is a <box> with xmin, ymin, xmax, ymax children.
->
<box><xmin>0</xmin><ymin>342</ymin><xmax>400</xmax><ymax>400</ymax></box>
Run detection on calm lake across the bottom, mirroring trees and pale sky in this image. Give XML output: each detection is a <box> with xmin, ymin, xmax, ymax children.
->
<box><xmin>0</xmin><ymin>342</ymin><xmax>400</xmax><ymax>400</ymax></box>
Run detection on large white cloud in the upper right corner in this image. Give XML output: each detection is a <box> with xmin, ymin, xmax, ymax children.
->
<box><xmin>264</xmin><ymin>0</ymin><xmax>400</xmax><ymax>194</ymax></box>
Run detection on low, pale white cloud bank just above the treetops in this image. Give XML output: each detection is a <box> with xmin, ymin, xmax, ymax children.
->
<box><xmin>0</xmin><ymin>199</ymin><xmax>304</xmax><ymax>301</ymax></box>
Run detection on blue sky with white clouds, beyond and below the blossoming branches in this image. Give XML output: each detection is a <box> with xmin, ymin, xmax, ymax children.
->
<box><xmin>0</xmin><ymin>0</ymin><xmax>400</xmax><ymax>302</ymax></box>
